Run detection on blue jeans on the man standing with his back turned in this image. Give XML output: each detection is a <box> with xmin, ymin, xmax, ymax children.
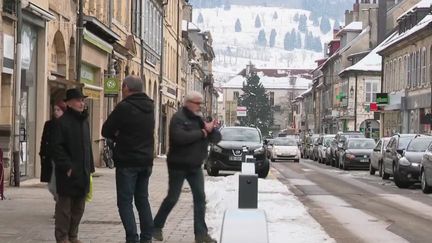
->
<box><xmin>116</xmin><ymin>166</ymin><xmax>153</xmax><ymax>243</ymax></box>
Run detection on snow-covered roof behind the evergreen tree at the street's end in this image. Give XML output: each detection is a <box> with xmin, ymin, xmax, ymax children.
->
<box><xmin>222</xmin><ymin>73</ymin><xmax>312</xmax><ymax>89</ymax></box>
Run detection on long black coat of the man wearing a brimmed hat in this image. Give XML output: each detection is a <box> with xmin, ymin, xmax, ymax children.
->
<box><xmin>52</xmin><ymin>108</ymin><xmax>95</xmax><ymax>197</ymax></box>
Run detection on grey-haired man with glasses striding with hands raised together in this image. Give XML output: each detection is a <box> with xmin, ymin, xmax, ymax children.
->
<box><xmin>153</xmin><ymin>91</ymin><xmax>221</xmax><ymax>243</ymax></box>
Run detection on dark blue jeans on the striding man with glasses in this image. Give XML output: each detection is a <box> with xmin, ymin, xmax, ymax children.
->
<box><xmin>154</xmin><ymin>168</ymin><xmax>208</xmax><ymax>235</ymax></box>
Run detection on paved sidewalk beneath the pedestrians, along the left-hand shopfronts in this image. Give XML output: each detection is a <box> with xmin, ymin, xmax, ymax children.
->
<box><xmin>0</xmin><ymin>159</ymin><xmax>194</xmax><ymax>243</ymax></box>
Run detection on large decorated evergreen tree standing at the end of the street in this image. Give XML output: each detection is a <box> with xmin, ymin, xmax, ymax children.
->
<box><xmin>239</xmin><ymin>74</ymin><xmax>273</xmax><ymax>134</ymax></box>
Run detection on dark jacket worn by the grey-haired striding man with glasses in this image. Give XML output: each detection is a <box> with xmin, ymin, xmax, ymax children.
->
<box><xmin>167</xmin><ymin>107</ymin><xmax>221</xmax><ymax>170</ymax></box>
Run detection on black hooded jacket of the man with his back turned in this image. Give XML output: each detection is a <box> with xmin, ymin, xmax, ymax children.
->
<box><xmin>102</xmin><ymin>93</ymin><xmax>155</xmax><ymax>168</ymax></box>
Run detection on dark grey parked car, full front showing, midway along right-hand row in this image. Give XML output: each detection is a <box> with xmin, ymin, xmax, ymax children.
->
<box><xmin>339</xmin><ymin>138</ymin><xmax>375</xmax><ymax>170</ymax></box>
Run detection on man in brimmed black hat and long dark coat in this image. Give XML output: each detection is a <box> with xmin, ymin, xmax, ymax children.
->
<box><xmin>52</xmin><ymin>89</ymin><xmax>95</xmax><ymax>243</ymax></box>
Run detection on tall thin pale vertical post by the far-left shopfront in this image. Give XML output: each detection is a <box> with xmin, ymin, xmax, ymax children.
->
<box><xmin>11</xmin><ymin>0</ymin><xmax>22</xmax><ymax>187</ymax></box>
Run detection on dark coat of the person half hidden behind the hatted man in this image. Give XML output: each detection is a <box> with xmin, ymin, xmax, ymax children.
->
<box><xmin>39</xmin><ymin>120</ymin><xmax>54</xmax><ymax>182</ymax></box>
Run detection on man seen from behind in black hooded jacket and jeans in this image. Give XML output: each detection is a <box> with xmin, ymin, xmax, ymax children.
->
<box><xmin>102</xmin><ymin>75</ymin><xmax>155</xmax><ymax>243</ymax></box>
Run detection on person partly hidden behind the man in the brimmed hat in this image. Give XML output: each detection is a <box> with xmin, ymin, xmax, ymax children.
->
<box><xmin>39</xmin><ymin>100</ymin><xmax>67</xmax><ymax>201</ymax></box>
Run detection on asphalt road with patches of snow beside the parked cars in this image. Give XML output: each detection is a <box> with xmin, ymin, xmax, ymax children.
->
<box><xmin>272</xmin><ymin>160</ymin><xmax>432</xmax><ymax>243</ymax></box>
